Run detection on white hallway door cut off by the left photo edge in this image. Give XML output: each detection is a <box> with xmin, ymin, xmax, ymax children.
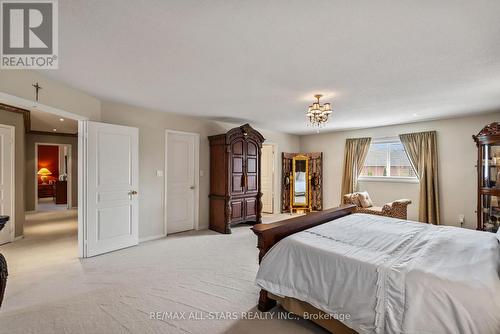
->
<box><xmin>0</xmin><ymin>126</ymin><xmax>14</xmax><ymax>245</ymax></box>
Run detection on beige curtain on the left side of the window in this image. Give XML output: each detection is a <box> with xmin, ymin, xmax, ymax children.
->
<box><xmin>341</xmin><ymin>138</ymin><xmax>372</xmax><ymax>196</ymax></box>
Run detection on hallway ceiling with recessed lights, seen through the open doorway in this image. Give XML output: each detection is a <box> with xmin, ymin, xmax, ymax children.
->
<box><xmin>30</xmin><ymin>109</ymin><xmax>78</xmax><ymax>134</ymax></box>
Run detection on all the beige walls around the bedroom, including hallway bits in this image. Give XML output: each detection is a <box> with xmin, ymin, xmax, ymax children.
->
<box><xmin>0</xmin><ymin>71</ymin><xmax>500</xmax><ymax>238</ymax></box>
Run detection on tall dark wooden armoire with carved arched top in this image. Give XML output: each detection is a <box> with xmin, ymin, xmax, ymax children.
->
<box><xmin>208</xmin><ymin>124</ymin><xmax>264</xmax><ymax>233</ymax></box>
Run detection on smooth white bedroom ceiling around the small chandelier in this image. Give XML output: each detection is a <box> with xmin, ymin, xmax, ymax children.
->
<box><xmin>42</xmin><ymin>0</ymin><xmax>500</xmax><ymax>134</ymax></box>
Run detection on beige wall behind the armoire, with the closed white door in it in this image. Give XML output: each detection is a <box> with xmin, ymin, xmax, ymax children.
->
<box><xmin>102</xmin><ymin>102</ymin><xmax>299</xmax><ymax>238</ymax></box>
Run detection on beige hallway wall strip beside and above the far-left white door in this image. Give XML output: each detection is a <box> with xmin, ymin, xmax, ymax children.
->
<box><xmin>0</xmin><ymin>110</ymin><xmax>24</xmax><ymax>237</ymax></box>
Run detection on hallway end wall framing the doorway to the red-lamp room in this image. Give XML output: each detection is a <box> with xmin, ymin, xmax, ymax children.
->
<box><xmin>25</xmin><ymin>134</ymin><xmax>78</xmax><ymax>211</ymax></box>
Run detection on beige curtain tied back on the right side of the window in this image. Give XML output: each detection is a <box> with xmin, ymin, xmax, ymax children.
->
<box><xmin>399</xmin><ymin>131</ymin><xmax>440</xmax><ymax>225</ymax></box>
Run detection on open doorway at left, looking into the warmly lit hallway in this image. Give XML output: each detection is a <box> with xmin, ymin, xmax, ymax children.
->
<box><xmin>0</xmin><ymin>99</ymin><xmax>79</xmax><ymax>266</ymax></box>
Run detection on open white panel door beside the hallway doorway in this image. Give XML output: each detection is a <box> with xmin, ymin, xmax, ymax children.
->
<box><xmin>84</xmin><ymin>122</ymin><xmax>139</xmax><ymax>257</ymax></box>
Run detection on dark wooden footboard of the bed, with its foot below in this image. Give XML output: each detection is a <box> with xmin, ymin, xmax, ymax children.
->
<box><xmin>252</xmin><ymin>204</ymin><xmax>356</xmax><ymax>312</ymax></box>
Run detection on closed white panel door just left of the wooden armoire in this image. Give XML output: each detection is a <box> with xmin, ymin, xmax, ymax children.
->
<box><xmin>166</xmin><ymin>131</ymin><xmax>198</xmax><ymax>234</ymax></box>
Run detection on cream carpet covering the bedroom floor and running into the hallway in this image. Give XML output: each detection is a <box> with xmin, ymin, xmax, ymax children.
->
<box><xmin>0</xmin><ymin>211</ymin><xmax>325</xmax><ymax>334</ymax></box>
